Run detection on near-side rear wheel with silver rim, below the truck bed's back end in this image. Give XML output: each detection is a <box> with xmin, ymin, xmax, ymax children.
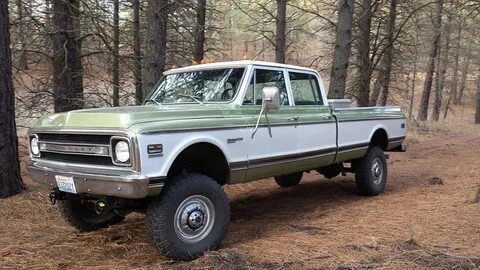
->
<box><xmin>355</xmin><ymin>146</ymin><xmax>387</xmax><ymax>196</ymax></box>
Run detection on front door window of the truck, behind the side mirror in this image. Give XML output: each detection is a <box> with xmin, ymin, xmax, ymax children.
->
<box><xmin>243</xmin><ymin>69</ymin><xmax>290</xmax><ymax>106</ymax></box>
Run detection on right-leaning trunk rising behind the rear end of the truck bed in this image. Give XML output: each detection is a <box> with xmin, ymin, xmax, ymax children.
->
<box><xmin>370</xmin><ymin>0</ymin><xmax>397</xmax><ymax>106</ymax></box>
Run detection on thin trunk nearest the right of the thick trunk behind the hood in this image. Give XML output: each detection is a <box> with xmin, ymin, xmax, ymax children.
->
<box><xmin>112</xmin><ymin>0</ymin><xmax>120</xmax><ymax>107</ymax></box>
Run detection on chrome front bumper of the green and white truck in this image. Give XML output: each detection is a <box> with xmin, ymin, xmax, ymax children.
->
<box><xmin>28</xmin><ymin>161</ymin><xmax>163</xmax><ymax>199</ymax></box>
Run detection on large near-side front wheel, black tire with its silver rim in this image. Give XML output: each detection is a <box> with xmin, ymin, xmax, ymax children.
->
<box><xmin>147</xmin><ymin>173</ymin><xmax>230</xmax><ymax>261</ymax></box>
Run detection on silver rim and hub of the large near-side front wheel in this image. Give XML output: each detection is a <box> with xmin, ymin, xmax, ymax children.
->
<box><xmin>174</xmin><ymin>195</ymin><xmax>215</xmax><ymax>243</ymax></box>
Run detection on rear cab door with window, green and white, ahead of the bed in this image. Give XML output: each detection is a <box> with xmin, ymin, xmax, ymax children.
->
<box><xmin>288</xmin><ymin>70</ymin><xmax>337</xmax><ymax>170</ymax></box>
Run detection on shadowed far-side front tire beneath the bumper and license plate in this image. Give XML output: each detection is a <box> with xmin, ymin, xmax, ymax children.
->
<box><xmin>57</xmin><ymin>199</ymin><xmax>125</xmax><ymax>231</ymax></box>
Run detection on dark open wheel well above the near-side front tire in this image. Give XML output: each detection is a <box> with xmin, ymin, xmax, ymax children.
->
<box><xmin>168</xmin><ymin>143</ymin><xmax>230</xmax><ymax>185</ymax></box>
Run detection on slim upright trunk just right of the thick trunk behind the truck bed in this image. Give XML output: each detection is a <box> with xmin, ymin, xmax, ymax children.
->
<box><xmin>357</xmin><ymin>0</ymin><xmax>372</xmax><ymax>107</ymax></box>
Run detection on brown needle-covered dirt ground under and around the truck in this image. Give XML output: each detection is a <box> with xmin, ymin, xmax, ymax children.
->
<box><xmin>0</xmin><ymin>107</ymin><xmax>480</xmax><ymax>269</ymax></box>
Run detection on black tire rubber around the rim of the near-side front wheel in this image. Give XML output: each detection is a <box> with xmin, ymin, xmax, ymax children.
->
<box><xmin>147</xmin><ymin>173</ymin><xmax>230</xmax><ymax>261</ymax></box>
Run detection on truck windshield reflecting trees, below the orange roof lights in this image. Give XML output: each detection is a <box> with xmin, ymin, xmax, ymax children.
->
<box><xmin>144</xmin><ymin>68</ymin><xmax>245</xmax><ymax>104</ymax></box>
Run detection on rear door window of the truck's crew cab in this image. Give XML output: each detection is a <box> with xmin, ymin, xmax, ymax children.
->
<box><xmin>288</xmin><ymin>72</ymin><xmax>323</xmax><ymax>106</ymax></box>
